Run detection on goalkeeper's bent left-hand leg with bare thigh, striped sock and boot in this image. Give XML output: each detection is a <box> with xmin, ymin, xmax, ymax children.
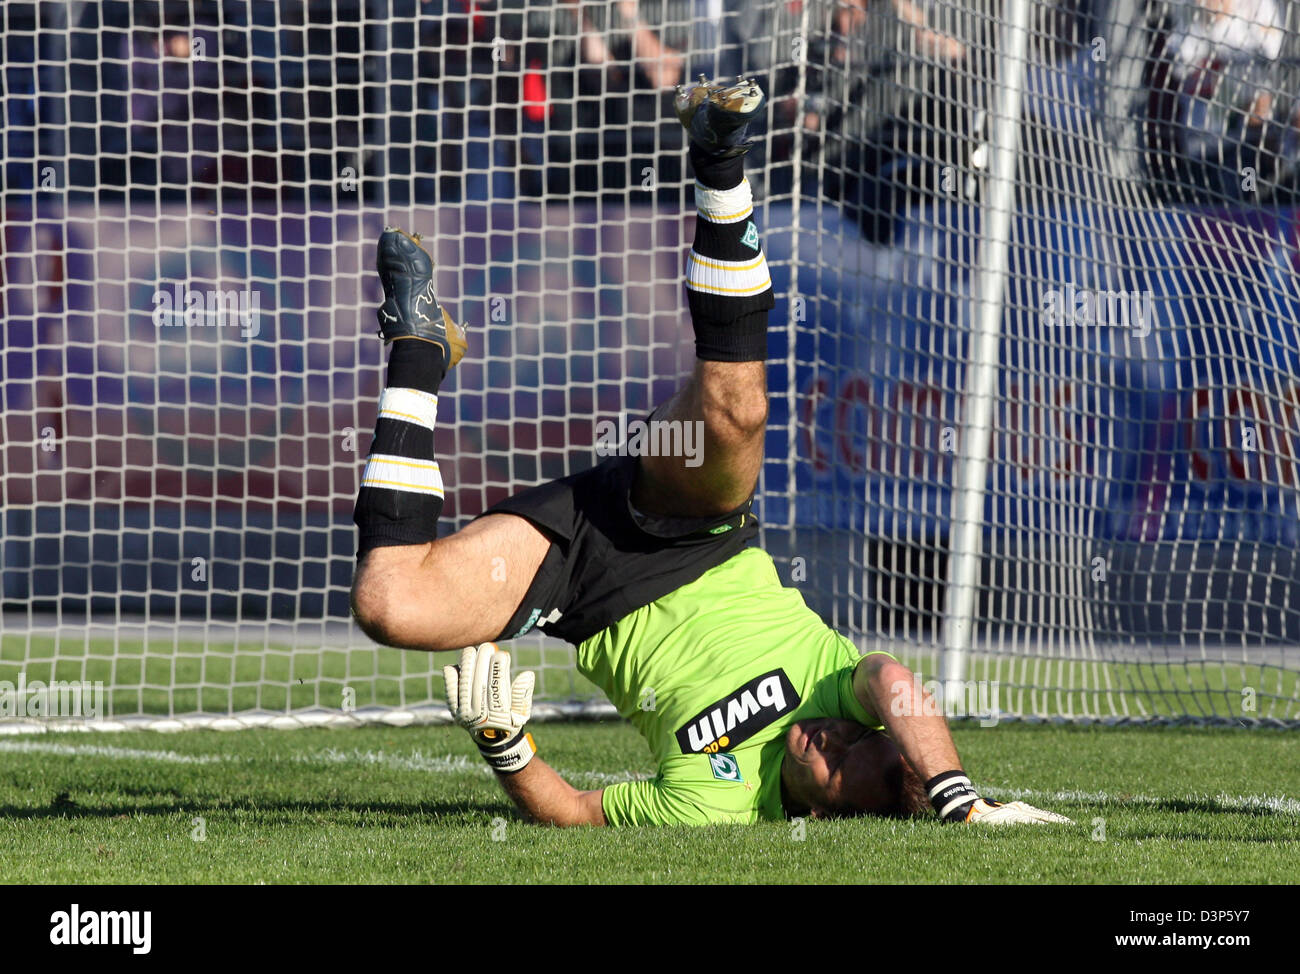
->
<box><xmin>352</xmin><ymin>228</ymin><xmax>550</xmax><ymax>650</ymax></box>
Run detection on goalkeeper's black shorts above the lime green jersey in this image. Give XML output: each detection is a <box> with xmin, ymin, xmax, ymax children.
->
<box><xmin>478</xmin><ymin>456</ymin><xmax>758</xmax><ymax>645</ymax></box>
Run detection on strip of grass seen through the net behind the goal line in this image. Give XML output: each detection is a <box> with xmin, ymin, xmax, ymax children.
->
<box><xmin>0</xmin><ymin>632</ymin><xmax>1300</xmax><ymax>722</ymax></box>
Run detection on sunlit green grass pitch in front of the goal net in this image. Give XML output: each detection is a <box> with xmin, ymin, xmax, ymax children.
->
<box><xmin>0</xmin><ymin>723</ymin><xmax>1300</xmax><ymax>883</ymax></box>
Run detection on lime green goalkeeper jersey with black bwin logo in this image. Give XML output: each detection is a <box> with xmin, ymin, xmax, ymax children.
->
<box><xmin>577</xmin><ymin>547</ymin><xmax>880</xmax><ymax>826</ymax></box>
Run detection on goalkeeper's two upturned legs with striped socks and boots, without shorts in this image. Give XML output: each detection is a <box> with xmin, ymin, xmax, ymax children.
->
<box><xmin>352</xmin><ymin>82</ymin><xmax>772</xmax><ymax>650</ymax></box>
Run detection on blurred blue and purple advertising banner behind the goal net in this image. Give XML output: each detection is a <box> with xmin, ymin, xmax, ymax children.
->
<box><xmin>0</xmin><ymin>203</ymin><xmax>1300</xmax><ymax>615</ymax></box>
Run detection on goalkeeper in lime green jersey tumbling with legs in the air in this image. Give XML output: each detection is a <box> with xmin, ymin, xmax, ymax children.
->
<box><xmin>352</xmin><ymin>81</ymin><xmax>1069</xmax><ymax>826</ymax></box>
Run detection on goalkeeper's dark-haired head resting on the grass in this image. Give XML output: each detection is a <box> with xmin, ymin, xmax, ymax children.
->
<box><xmin>781</xmin><ymin>717</ymin><xmax>902</xmax><ymax>817</ymax></box>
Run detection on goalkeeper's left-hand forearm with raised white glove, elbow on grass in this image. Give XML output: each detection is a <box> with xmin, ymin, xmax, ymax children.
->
<box><xmin>442</xmin><ymin>642</ymin><xmax>606</xmax><ymax>826</ymax></box>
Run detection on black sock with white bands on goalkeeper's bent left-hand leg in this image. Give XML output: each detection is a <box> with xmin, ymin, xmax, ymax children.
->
<box><xmin>352</xmin><ymin>338</ymin><xmax>446</xmax><ymax>558</ymax></box>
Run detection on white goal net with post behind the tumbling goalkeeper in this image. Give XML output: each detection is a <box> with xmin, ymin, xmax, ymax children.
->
<box><xmin>0</xmin><ymin>0</ymin><xmax>1300</xmax><ymax>730</ymax></box>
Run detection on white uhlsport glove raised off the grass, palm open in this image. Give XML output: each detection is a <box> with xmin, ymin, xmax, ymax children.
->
<box><xmin>442</xmin><ymin>642</ymin><xmax>537</xmax><ymax>772</ymax></box>
